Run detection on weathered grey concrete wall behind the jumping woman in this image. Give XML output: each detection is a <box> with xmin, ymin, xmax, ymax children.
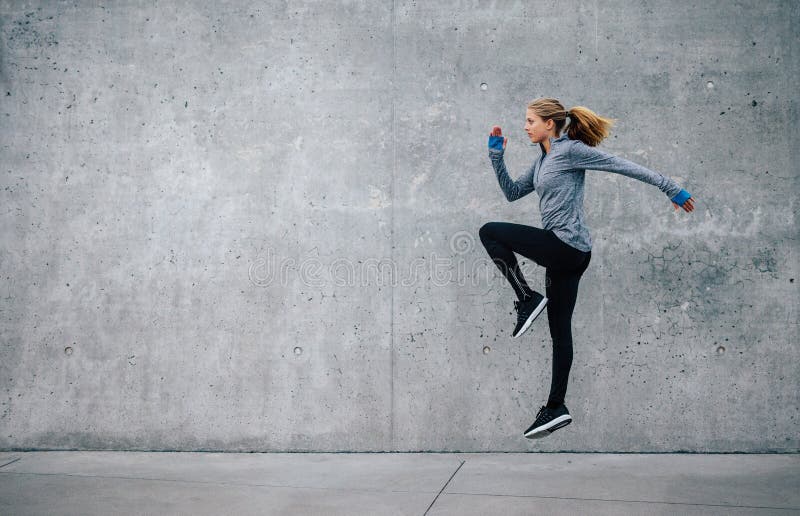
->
<box><xmin>0</xmin><ymin>0</ymin><xmax>800</xmax><ymax>452</ymax></box>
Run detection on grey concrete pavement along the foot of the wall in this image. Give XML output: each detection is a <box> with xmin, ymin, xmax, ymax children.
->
<box><xmin>0</xmin><ymin>451</ymin><xmax>800</xmax><ymax>516</ymax></box>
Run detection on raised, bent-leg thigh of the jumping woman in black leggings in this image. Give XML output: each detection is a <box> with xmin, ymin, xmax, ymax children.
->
<box><xmin>482</xmin><ymin>222</ymin><xmax>564</xmax><ymax>268</ymax></box>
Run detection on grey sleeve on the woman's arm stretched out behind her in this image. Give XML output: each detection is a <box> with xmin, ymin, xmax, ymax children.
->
<box><xmin>569</xmin><ymin>140</ymin><xmax>681</xmax><ymax>198</ymax></box>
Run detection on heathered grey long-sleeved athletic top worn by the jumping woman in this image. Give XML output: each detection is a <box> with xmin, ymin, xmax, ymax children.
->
<box><xmin>489</xmin><ymin>133</ymin><xmax>681</xmax><ymax>252</ymax></box>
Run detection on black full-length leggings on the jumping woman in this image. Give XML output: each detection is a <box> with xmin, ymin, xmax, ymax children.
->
<box><xmin>479</xmin><ymin>222</ymin><xmax>592</xmax><ymax>407</ymax></box>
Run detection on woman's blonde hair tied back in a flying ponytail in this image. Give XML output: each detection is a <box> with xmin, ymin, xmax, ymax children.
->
<box><xmin>528</xmin><ymin>97</ymin><xmax>616</xmax><ymax>147</ymax></box>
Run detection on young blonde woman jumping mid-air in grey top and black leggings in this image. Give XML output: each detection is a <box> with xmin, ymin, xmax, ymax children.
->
<box><xmin>480</xmin><ymin>98</ymin><xmax>694</xmax><ymax>438</ymax></box>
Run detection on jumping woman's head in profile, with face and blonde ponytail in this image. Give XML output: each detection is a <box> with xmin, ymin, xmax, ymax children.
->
<box><xmin>525</xmin><ymin>97</ymin><xmax>614</xmax><ymax>146</ymax></box>
